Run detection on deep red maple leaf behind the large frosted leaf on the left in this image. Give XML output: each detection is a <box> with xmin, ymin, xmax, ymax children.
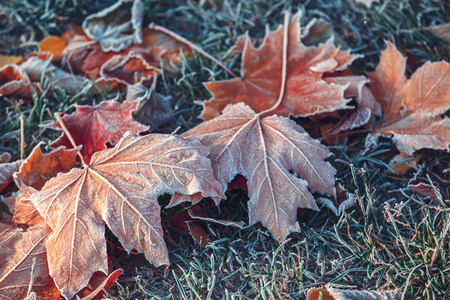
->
<box><xmin>45</xmin><ymin>100</ymin><xmax>149</xmax><ymax>163</ymax></box>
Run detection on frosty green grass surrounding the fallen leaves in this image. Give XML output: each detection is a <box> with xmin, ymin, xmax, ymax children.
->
<box><xmin>0</xmin><ymin>0</ymin><xmax>450</xmax><ymax>299</ymax></box>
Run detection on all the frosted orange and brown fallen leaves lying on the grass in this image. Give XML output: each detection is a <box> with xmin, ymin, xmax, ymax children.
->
<box><xmin>0</xmin><ymin>0</ymin><xmax>450</xmax><ymax>299</ymax></box>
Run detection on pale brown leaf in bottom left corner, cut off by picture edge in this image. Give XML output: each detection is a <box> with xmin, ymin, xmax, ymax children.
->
<box><xmin>0</xmin><ymin>223</ymin><xmax>60</xmax><ymax>300</ymax></box>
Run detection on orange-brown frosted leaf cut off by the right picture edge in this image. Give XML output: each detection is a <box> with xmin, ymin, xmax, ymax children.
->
<box><xmin>367</xmin><ymin>43</ymin><xmax>450</xmax><ymax>169</ymax></box>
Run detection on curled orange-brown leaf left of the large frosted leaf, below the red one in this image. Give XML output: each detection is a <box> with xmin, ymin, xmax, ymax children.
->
<box><xmin>8</xmin><ymin>143</ymin><xmax>80</xmax><ymax>226</ymax></box>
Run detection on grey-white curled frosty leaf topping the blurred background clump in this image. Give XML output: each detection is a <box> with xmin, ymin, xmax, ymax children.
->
<box><xmin>82</xmin><ymin>0</ymin><xmax>144</xmax><ymax>52</ymax></box>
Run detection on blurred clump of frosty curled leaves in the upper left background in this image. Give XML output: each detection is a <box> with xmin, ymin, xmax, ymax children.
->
<box><xmin>0</xmin><ymin>0</ymin><xmax>192</xmax><ymax>99</ymax></box>
